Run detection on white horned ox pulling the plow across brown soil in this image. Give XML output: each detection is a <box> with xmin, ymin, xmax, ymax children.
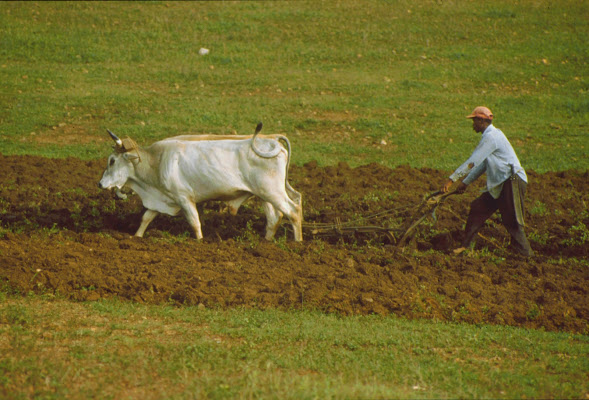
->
<box><xmin>98</xmin><ymin>123</ymin><xmax>303</xmax><ymax>241</ymax></box>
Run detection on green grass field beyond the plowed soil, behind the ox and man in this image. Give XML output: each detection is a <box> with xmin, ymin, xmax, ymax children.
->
<box><xmin>0</xmin><ymin>1</ymin><xmax>589</xmax><ymax>172</ymax></box>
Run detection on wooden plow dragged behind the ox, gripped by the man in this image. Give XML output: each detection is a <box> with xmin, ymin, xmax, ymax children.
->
<box><xmin>303</xmin><ymin>191</ymin><xmax>456</xmax><ymax>247</ymax></box>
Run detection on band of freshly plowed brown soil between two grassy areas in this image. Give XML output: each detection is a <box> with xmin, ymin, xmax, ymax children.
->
<box><xmin>0</xmin><ymin>155</ymin><xmax>589</xmax><ymax>333</ymax></box>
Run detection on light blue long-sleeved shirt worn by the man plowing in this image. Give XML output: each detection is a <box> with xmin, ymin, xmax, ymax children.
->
<box><xmin>450</xmin><ymin>125</ymin><xmax>528</xmax><ymax>199</ymax></box>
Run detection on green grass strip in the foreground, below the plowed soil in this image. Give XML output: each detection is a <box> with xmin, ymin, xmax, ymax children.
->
<box><xmin>0</xmin><ymin>296</ymin><xmax>589</xmax><ymax>399</ymax></box>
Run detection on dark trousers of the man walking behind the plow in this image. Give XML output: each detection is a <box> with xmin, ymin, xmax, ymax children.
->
<box><xmin>462</xmin><ymin>176</ymin><xmax>533</xmax><ymax>256</ymax></box>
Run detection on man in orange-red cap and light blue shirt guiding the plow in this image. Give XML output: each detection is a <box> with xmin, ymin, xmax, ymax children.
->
<box><xmin>441</xmin><ymin>107</ymin><xmax>533</xmax><ymax>257</ymax></box>
